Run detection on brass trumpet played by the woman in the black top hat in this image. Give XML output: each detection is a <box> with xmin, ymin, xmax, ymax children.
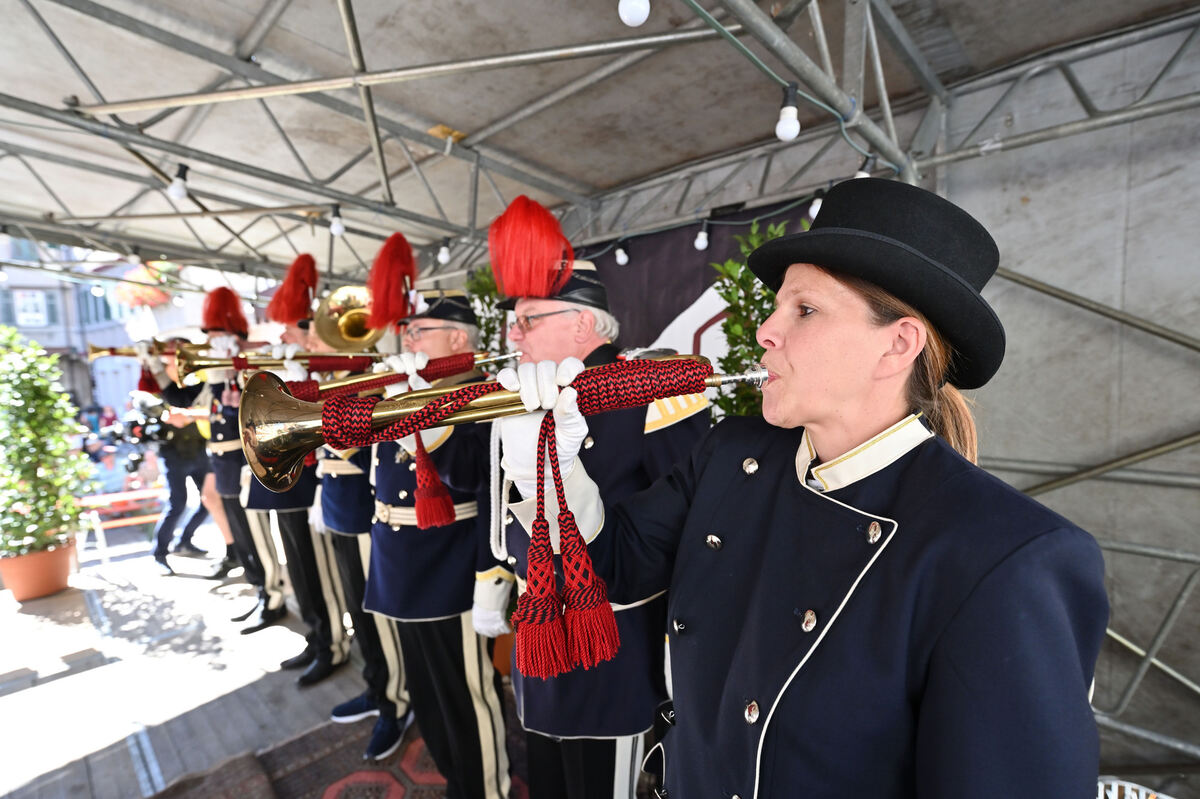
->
<box><xmin>238</xmin><ymin>355</ymin><xmax>767</xmax><ymax>492</ymax></box>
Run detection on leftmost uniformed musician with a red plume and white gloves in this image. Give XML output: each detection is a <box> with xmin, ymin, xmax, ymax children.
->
<box><xmin>156</xmin><ymin>286</ymin><xmax>288</xmax><ymax>633</ymax></box>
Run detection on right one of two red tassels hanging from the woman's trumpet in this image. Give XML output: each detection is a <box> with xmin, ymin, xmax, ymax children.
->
<box><xmin>558</xmin><ymin>510</ymin><xmax>620</xmax><ymax>668</ymax></box>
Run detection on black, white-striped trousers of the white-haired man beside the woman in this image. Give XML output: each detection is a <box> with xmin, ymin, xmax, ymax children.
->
<box><xmin>526</xmin><ymin>732</ymin><xmax>642</xmax><ymax>799</ymax></box>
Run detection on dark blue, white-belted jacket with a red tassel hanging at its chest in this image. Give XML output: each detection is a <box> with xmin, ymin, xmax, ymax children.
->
<box><xmin>364</xmin><ymin>372</ymin><xmax>502</xmax><ymax>621</ymax></box>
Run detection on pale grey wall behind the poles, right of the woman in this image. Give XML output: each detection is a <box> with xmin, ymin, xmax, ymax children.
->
<box><xmin>937</xmin><ymin>23</ymin><xmax>1200</xmax><ymax>777</ymax></box>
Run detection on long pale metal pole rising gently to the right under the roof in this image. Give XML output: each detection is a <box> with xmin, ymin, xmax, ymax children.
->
<box><xmin>70</xmin><ymin>26</ymin><xmax>744</xmax><ymax>114</ymax></box>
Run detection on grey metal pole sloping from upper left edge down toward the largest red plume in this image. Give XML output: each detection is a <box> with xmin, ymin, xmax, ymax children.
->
<box><xmin>0</xmin><ymin>94</ymin><xmax>467</xmax><ymax>235</ymax></box>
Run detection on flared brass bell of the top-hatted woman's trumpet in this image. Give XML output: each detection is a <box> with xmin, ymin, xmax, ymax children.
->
<box><xmin>238</xmin><ymin>372</ymin><xmax>325</xmax><ymax>493</ymax></box>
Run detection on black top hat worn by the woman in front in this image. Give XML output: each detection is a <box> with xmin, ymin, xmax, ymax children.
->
<box><xmin>748</xmin><ymin>178</ymin><xmax>1004</xmax><ymax>389</ymax></box>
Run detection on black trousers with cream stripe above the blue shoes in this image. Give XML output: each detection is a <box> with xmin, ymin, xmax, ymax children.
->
<box><xmin>324</xmin><ymin>533</ymin><xmax>409</xmax><ymax>719</ymax></box>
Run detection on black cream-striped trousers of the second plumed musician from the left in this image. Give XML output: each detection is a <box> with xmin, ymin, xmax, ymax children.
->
<box><xmin>246</xmin><ymin>507</ymin><xmax>350</xmax><ymax>663</ymax></box>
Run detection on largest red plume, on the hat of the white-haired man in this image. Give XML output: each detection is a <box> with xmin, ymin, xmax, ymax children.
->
<box><xmin>487</xmin><ymin>194</ymin><xmax>575</xmax><ymax>298</ymax></box>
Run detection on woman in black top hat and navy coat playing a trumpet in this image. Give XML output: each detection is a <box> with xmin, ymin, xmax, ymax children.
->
<box><xmin>503</xmin><ymin>179</ymin><xmax>1108</xmax><ymax>799</ymax></box>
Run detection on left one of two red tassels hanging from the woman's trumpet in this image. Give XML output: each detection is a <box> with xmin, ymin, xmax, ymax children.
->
<box><xmin>512</xmin><ymin>517</ymin><xmax>571</xmax><ymax>679</ymax></box>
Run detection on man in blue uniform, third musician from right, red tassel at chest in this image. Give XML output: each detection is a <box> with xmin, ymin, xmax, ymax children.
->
<box><xmin>365</xmin><ymin>286</ymin><xmax>511</xmax><ymax>799</ymax></box>
